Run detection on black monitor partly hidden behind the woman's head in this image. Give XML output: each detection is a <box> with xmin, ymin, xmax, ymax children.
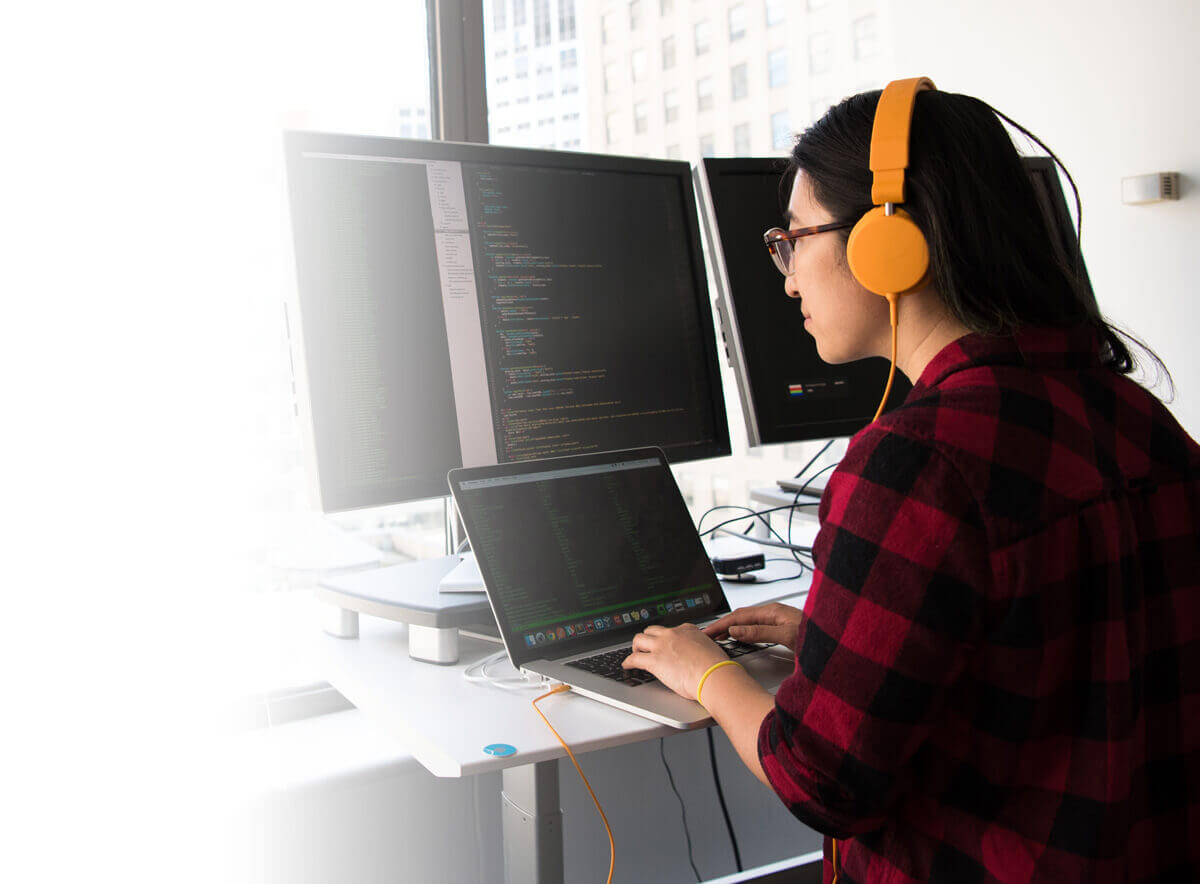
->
<box><xmin>696</xmin><ymin>157</ymin><xmax>1090</xmax><ymax>446</ymax></box>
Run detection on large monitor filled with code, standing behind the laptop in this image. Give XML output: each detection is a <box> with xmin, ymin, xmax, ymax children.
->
<box><xmin>286</xmin><ymin>132</ymin><xmax>730</xmax><ymax>511</ymax></box>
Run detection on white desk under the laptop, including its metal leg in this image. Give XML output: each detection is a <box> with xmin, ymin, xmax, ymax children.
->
<box><xmin>320</xmin><ymin>575</ymin><xmax>810</xmax><ymax>884</ymax></box>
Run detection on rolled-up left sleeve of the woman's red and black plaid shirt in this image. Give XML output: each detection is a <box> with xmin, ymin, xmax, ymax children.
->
<box><xmin>758</xmin><ymin>423</ymin><xmax>991</xmax><ymax>837</ymax></box>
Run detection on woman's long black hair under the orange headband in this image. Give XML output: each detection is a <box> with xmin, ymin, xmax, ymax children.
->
<box><xmin>781</xmin><ymin>90</ymin><xmax>1170</xmax><ymax>380</ymax></box>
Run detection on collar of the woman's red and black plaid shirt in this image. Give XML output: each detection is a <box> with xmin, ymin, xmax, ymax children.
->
<box><xmin>916</xmin><ymin>326</ymin><xmax>1100</xmax><ymax>387</ymax></box>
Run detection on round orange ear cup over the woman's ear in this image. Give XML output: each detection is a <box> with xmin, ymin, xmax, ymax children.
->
<box><xmin>846</xmin><ymin>206</ymin><xmax>929</xmax><ymax>295</ymax></box>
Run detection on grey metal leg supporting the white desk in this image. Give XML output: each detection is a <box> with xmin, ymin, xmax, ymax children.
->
<box><xmin>500</xmin><ymin>760</ymin><xmax>563</xmax><ymax>884</ymax></box>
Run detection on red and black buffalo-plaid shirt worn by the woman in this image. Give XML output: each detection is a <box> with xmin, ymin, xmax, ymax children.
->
<box><xmin>758</xmin><ymin>330</ymin><xmax>1200</xmax><ymax>884</ymax></box>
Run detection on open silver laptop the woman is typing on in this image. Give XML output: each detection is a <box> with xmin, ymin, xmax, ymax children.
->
<box><xmin>449</xmin><ymin>447</ymin><xmax>793</xmax><ymax>728</ymax></box>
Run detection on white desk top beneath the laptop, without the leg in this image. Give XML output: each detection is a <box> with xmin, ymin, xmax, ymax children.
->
<box><xmin>319</xmin><ymin>575</ymin><xmax>810</xmax><ymax>777</ymax></box>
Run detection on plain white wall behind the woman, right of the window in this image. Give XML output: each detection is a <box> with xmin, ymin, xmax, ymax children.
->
<box><xmin>889</xmin><ymin>0</ymin><xmax>1200</xmax><ymax>438</ymax></box>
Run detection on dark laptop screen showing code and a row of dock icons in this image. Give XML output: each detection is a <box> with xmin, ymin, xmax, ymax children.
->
<box><xmin>456</xmin><ymin>457</ymin><xmax>727</xmax><ymax>650</ymax></box>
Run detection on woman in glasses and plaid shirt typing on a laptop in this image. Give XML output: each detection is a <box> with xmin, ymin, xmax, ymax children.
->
<box><xmin>625</xmin><ymin>80</ymin><xmax>1200</xmax><ymax>882</ymax></box>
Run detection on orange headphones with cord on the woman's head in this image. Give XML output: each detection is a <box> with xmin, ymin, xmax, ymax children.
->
<box><xmin>846</xmin><ymin>77</ymin><xmax>936</xmax><ymax>421</ymax></box>
